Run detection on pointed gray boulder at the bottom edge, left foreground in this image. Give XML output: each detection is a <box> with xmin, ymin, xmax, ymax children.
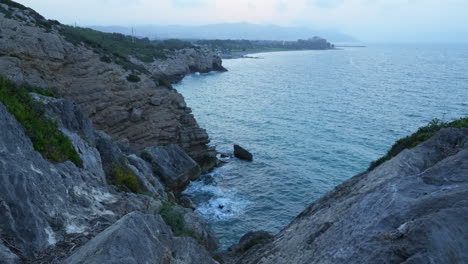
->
<box><xmin>63</xmin><ymin>213</ymin><xmax>216</xmax><ymax>264</ymax></box>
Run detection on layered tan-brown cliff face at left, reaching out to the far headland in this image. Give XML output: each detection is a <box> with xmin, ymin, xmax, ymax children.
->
<box><xmin>0</xmin><ymin>4</ymin><xmax>222</xmax><ymax>170</ymax></box>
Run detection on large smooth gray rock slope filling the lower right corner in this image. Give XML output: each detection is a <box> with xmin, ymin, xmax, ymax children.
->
<box><xmin>227</xmin><ymin>128</ymin><xmax>468</xmax><ymax>264</ymax></box>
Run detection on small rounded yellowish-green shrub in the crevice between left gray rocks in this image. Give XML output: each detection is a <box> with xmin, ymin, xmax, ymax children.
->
<box><xmin>107</xmin><ymin>161</ymin><xmax>142</xmax><ymax>193</ymax></box>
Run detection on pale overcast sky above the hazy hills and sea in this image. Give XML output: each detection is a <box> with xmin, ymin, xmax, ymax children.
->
<box><xmin>19</xmin><ymin>0</ymin><xmax>468</xmax><ymax>42</ymax></box>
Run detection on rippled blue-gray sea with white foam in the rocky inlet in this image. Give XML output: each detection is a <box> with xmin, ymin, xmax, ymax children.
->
<box><xmin>175</xmin><ymin>44</ymin><xmax>468</xmax><ymax>248</ymax></box>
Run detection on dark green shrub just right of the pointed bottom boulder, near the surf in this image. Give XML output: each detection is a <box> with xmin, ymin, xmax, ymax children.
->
<box><xmin>159</xmin><ymin>202</ymin><xmax>203</xmax><ymax>244</ymax></box>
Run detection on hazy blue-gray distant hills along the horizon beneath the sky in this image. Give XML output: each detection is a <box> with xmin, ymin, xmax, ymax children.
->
<box><xmin>91</xmin><ymin>23</ymin><xmax>358</xmax><ymax>42</ymax></box>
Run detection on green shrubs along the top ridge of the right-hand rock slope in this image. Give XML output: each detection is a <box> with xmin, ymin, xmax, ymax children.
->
<box><xmin>367</xmin><ymin>117</ymin><xmax>468</xmax><ymax>171</ymax></box>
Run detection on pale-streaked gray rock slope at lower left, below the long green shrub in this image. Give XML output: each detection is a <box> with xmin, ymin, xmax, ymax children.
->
<box><xmin>0</xmin><ymin>98</ymin><xmax>176</xmax><ymax>263</ymax></box>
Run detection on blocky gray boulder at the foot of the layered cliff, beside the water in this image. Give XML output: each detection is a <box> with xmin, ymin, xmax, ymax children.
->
<box><xmin>144</xmin><ymin>145</ymin><xmax>201</xmax><ymax>192</ymax></box>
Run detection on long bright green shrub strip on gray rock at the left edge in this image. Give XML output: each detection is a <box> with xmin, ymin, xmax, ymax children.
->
<box><xmin>0</xmin><ymin>78</ymin><xmax>83</xmax><ymax>167</ymax></box>
